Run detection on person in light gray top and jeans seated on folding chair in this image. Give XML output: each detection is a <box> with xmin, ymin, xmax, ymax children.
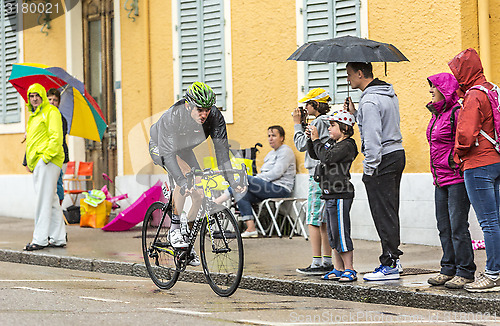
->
<box><xmin>215</xmin><ymin>126</ymin><xmax>296</xmax><ymax>238</ymax></box>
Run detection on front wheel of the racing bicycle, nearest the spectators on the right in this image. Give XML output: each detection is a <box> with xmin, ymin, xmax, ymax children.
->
<box><xmin>200</xmin><ymin>208</ymin><xmax>244</xmax><ymax>297</ymax></box>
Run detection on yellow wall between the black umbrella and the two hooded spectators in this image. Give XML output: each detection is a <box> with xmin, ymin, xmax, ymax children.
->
<box><xmin>368</xmin><ymin>0</ymin><xmax>478</xmax><ymax>173</ymax></box>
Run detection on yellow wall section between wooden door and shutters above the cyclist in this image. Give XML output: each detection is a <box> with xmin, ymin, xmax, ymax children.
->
<box><xmin>120</xmin><ymin>0</ymin><xmax>174</xmax><ymax>174</ymax></box>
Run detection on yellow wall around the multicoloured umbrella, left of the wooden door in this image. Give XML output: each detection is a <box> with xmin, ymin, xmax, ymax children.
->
<box><xmin>0</xmin><ymin>14</ymin><xmax>66</xmax><ymax>174</ymax></box>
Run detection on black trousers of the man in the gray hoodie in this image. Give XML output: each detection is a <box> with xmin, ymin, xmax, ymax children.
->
<box><xmin>362</xmin><ymin>150</ymin><xmax>406</xmax><ymax>266</ymax></box>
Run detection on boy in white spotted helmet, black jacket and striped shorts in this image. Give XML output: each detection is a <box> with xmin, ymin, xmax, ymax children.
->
<box><xmin>307</xmin><ymin>110</ymin><xmax>358</xmax><ymax>282</ymax></box>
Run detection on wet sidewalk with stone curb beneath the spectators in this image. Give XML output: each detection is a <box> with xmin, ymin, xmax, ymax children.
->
<box><xmin>0</xmin><ymin>217</ymin><xmax>500</xmax><ymax>315</ymax></box>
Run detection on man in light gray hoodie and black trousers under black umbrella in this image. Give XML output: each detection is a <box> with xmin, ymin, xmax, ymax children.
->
<box><xmin>344</xmin><ymin>62</ymin><xmax>405</xmax><ymax>281</ymax></box>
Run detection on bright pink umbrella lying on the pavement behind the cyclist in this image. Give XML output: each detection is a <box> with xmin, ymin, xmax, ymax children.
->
<box><xmin>102</xmin><ymin>181</ymin><xmax>170</xmax><ymax>231</ymax></box>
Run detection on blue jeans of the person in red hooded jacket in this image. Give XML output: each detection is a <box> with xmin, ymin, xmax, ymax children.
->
<box><xmin>464</xmin><ymin>163</ymin><xmax>500</xmax><ymax>275</ymax></box>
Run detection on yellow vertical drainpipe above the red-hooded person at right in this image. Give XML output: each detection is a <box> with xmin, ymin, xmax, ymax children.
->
<box><xmin>477</xmin><ymin>0</ymin><xmax>491</xmax><ymax>80</ymax></box>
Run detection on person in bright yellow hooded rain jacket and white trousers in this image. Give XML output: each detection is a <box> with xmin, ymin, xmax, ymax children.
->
<box><xmin>24</xmin><ymin>84</ymin><xmax>66</xmax><ymax>251</ymax></box>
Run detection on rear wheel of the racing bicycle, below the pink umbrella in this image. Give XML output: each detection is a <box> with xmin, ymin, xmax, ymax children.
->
<box><xmin>142</xmin><ymin>202</ymin><xmax>179</xmax><ymax>289</ymax></box>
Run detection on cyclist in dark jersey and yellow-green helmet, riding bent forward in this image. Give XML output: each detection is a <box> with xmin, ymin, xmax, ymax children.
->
<box><xmin>149</xmin><ymin>82</ymin><xmax>245</xmax><ymax>255</ymax></box>
